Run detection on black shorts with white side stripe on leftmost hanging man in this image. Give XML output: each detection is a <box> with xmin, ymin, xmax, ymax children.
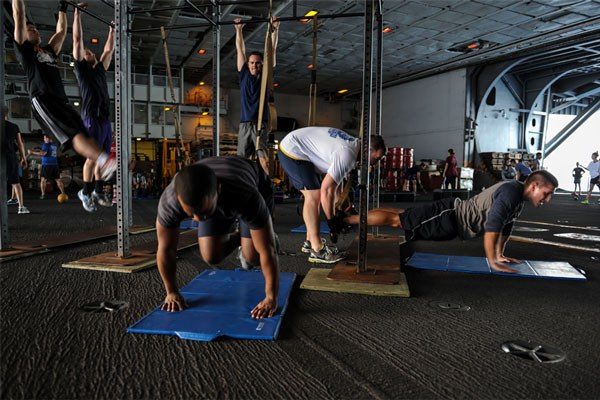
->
<box><xmin>31</xmin><ymin>95</ymin><xmax>88</xmax><ymax>150</ymax></box>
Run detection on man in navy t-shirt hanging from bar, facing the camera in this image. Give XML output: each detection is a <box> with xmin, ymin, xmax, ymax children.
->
<box><xmin>234</xmin><ymin>17</ymin><xmax>279</xmax><ymax>171</ymax></box>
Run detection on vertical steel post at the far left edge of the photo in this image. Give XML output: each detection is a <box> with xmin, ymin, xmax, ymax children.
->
<box><xmin>0</xmin><ymin>4</ymin><xmax>8</xmax><ymax>250</ymax></box>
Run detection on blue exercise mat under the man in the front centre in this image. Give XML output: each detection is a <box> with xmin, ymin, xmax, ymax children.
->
<box><xmin>127</xmin><ymin>269</ymin><xmax>296</xmax><ymax>342</ymax></box>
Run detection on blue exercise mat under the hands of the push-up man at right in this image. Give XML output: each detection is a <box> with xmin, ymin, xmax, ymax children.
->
<box><xmin>406</xmin><ymin>253</ymin><xmax>586</xmax><ymax>281</ymax></box>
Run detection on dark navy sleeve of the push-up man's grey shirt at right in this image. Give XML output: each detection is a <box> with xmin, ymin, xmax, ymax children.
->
<box><xmin>483</xmin><ymin>181</ymin><xmax>524</xmax><ymax>236</ymax></box>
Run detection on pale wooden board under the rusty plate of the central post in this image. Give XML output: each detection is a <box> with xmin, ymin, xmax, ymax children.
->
<box><xmin>300</xmin><ymin>268</ymin><xmax>410</xmax><ymax>297</ymax></box>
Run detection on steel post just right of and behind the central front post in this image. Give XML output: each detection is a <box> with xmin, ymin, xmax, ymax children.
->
<box><xmin>373</xmin><ymin>0</ymin><xmax>383</xmax><ymax>236</ymax></box>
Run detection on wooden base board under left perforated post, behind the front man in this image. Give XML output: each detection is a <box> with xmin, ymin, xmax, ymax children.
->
<box><xmin>62</xmin><ymin>231</ymin><xmax>198</xmax><ymax>273</ymax></box>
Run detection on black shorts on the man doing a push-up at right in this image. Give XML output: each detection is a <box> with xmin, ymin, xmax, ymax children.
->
<box><xmin>400</xmin><ymin>198</ymin><xmax>460</xmax><ymax>240</ymax></box>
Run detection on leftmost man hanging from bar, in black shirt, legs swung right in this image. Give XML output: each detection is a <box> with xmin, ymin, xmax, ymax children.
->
<box><xmin>12</xmin><ymin>0</ymin><xmax>117</xmax><ymax>191</ymax></box>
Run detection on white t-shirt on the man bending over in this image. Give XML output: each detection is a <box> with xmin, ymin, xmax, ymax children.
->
<box><xmin>279</xmin><ymin>126</ymin><xmax>360</xmax><ymax>184</ymax></box>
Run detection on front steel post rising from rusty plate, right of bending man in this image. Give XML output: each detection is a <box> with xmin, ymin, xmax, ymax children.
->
<box><xmin>356</xmin><ymin>0</ymin><xmax>376</xmax><ymax>272</ymax></box>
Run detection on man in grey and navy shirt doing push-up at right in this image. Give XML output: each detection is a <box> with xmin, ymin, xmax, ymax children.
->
<box><xmin>344</xmin><ymin>170</ymin><xmax>558</xmax><ymax>272</ymax></box>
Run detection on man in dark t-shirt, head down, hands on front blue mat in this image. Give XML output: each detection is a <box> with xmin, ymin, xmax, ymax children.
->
<box><xmin>156</xmin><ymin>157</ymin><xmax>279</xmax><ymax>318</ymax></box>
